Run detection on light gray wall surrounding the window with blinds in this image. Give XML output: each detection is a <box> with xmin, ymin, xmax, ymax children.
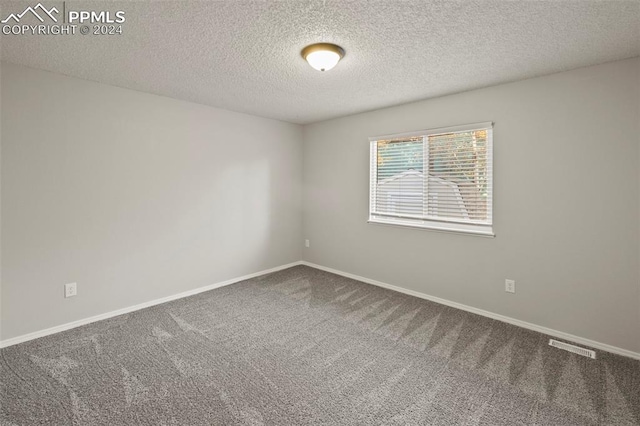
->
<box><xmin>303</xmin><ymin>58</ymin><xmax>640</xmax><ymax>352</ymax></box>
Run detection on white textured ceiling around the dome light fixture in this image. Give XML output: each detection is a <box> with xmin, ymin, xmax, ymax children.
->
<box><xmin>0</xmin><ymin>0</ymin><xmax>640</xmax><ymax>123</ymax></box>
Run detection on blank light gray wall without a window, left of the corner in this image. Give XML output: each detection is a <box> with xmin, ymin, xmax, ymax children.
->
<box><xmin>1</xmin><ymin>63</ymin><xmax>302</xmax><ymax>339</ymax></box>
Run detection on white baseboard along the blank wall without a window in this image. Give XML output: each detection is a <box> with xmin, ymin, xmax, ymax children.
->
<box><xmin>0</xmin><ymin>261</ymin><xmax>302</xmax><ymax>348</ymax></box>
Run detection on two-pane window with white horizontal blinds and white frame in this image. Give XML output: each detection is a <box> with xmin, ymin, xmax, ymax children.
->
<box><xmin>369</xmin><ymin>123</ymin><xmax>493</xmax><ymax>236</ymax></box>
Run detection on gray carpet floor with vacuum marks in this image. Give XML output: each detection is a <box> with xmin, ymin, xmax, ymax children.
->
<box><xmin>0</xmin><ymin>266</ymin><xmax>640</xmax><ymax>426</ymax></box>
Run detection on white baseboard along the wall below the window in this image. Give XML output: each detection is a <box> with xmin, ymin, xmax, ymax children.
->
<box><xmin>300</xmin><ymin>261</ymin><xmax>640</xmax><ymax>360</ymax></box>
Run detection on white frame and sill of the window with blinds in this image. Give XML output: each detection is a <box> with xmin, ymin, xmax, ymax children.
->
<box><xmin>367</xmin><ymin>121</ymin><xmax>495</xmax><ymax>237</ymax></box>
